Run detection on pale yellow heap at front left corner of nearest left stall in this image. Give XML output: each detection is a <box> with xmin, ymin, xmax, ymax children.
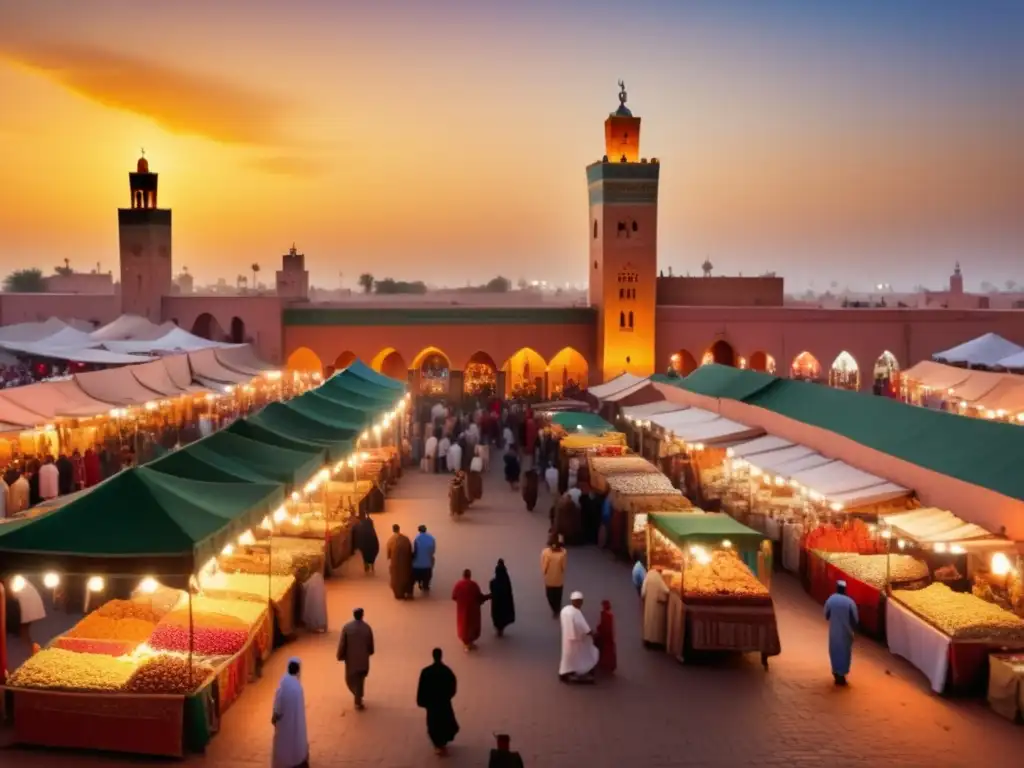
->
<box><xmin>7</xmin><ymin>648</ymin><xmax>136</xmax><ymax>691</ymax></box>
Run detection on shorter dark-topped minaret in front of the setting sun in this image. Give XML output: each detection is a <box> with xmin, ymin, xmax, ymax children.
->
<box><xmin>118</xmin><ymin>152</ymin><xmax>174</xmax><ymax>323</ymax></box>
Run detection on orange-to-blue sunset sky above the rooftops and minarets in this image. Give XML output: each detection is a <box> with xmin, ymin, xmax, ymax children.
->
<box><xmin>0</xmin><ymin>0</ymin><xmax>1024</xmax><ymax>289</ymax></box>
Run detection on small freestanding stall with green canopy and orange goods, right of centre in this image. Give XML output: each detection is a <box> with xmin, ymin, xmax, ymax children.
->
<box><xmin>647</xmin><ymin>514</ymin><xmax>781</xmax><ymax>669</ymax></box>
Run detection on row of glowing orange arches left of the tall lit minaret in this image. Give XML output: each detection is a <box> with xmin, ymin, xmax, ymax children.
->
<box><xmin>287</xmin><ymin>346</ymin><xmax>590</xmax><ymax>398</ymax></box>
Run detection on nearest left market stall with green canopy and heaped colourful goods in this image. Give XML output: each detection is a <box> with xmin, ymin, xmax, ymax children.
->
<box><xmin>0</xmin><ymin>468</ymin><xmax>283</xmax><ymax>757</ymax></box>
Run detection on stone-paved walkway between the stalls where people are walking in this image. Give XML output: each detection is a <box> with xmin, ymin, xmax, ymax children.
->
<box><xmin>0</xmin><ymin>472</ymin><xmax>1024</xmax><ymax>768</ymax></box>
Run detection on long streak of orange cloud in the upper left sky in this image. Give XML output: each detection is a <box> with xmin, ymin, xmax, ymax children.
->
<box><xmin>0</xmin><ymin>37</ymin><xmax>295</xmax><ymax>146</ymax></box>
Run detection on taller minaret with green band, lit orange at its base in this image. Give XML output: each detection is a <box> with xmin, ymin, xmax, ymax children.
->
<box><xmin>587</xmin><ymin>81</ymin><xmax>660</xmax><ymax>381</ymax></box>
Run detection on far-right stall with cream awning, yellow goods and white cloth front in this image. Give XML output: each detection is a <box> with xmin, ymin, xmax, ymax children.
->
<box><xmin>882</xmin><ymin>508</ymin><xmax>1024</xmax><ymax>693</ymax></box>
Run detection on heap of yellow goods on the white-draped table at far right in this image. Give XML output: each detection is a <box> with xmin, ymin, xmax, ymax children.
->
<box><xmin>892</xmin><ymin>584</ymin><xmax>1024</xmax><ymax>643</ymax></box>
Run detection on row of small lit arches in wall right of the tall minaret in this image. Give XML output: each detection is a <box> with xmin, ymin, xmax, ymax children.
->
<box><xmin>669</xmin><ymin>339</ymin><xmax>900</xmax><ymax>394</ymax></box>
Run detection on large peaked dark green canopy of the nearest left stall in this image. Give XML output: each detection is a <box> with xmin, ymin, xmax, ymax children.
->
<box><xmin>0</xmin><ymin>467</ymin><xmax>284</xmax><ymax>575</ymax></box>
